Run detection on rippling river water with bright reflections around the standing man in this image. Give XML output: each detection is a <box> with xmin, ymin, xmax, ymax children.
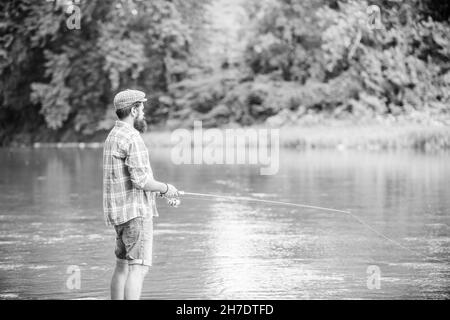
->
<box><xmin>0</xmin><ymin>149</ymin><xmax>450</xmax><ymax>299</ymax></box>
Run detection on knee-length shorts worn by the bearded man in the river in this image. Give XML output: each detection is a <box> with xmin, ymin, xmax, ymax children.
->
<box><xmin>114</xmin><ymin>217</ymin><xmax>153</xmax><ymax>266</ymax></box>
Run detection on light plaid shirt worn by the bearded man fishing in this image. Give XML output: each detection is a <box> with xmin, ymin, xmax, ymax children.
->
<box><xmin>103</xmin><ymin>121</ymin><xmax>158</xmax><ymax>225</ymax></box>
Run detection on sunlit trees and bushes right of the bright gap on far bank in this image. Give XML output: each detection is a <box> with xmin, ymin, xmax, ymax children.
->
<box><xmin>169</xmin><ymin>0</ymin><xmax>450</xmax><ymax>126</ymax></box>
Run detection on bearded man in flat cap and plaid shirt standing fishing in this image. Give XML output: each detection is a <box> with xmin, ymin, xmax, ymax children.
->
<box><xmin>103</xmin><ymin>90</ymin><xmax>178</xmax><ymax>300</ymax></box>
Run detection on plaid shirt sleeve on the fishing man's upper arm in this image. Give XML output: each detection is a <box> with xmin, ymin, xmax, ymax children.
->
<box><xmin>125</xmin><ymin>137</ymin><xmax>151</xmax><ymax>189</ymax></box>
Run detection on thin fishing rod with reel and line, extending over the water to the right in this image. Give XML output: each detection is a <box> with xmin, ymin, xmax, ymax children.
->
<box><xmin>160</xmin><ymin>191</ymin><xmax>447</xmax><ymax>263</ymax></box>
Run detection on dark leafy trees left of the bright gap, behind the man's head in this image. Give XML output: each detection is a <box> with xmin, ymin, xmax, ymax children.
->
<box><xmin>0</xmin><ymin>0</ymin><xmax>206</xmax><ymax>144</ymax></box>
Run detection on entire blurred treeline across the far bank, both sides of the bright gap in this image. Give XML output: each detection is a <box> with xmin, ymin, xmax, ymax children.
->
<box><xmin>0</xmin><ymin>0</ymin><xmax>450</xmax><ymax>145</ymax></box>
